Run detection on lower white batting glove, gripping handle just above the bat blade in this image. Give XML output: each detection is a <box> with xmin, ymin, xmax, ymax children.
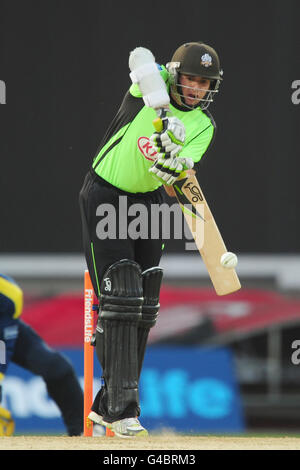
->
<box><xmin>149</xmin><ymin>157</ymin><xmax>194</xmax><ymax>186</ymax></box>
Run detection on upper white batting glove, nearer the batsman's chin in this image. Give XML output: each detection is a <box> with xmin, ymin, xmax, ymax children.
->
<box><xmin>150</xmin><ymin>116</ymin><xmax>185</xmax><ymax>158</ymax></box>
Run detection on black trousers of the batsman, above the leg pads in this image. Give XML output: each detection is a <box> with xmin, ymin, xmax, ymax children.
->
<box><xmin>79</xmin><ymin>170</ymin><xmax>164</xmax><ymax>297</ymax></box>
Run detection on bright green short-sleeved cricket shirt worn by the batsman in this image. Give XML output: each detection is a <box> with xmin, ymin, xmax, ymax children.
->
<box><xmin>93</xmin><ymin>97</ymin><xmax>214</xmax><ymax>193</ymax></box>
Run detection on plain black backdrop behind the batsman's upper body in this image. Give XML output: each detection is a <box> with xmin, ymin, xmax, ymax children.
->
<box><xmin>0</xmin><ymin>0</ymin><xmax>300</xmax><ymax>253</ymax></box>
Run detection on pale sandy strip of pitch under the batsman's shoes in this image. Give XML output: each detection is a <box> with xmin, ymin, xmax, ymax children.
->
<box><xmin>0</xmin><ymin>433</ymin><xmax>300</xmax><ymax>450</ymax></box>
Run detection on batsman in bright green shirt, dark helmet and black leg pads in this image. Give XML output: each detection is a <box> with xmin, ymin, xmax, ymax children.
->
<box><xmin>79</xmin><ymin>42</ymin><xmax>222</xmax><ymax>438</ymax></box>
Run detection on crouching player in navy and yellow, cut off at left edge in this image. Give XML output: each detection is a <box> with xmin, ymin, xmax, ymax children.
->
<box><xmin>0</xmin><ymin>274</ymin><xmax>83</xmax><ymax>436</ymax></box>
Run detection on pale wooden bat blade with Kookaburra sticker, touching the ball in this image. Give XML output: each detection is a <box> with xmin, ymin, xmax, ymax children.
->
<box><xmin>174</xmin><ymin>176</ymin><xmax>241</xmax><ymax>295</ymax></box>
